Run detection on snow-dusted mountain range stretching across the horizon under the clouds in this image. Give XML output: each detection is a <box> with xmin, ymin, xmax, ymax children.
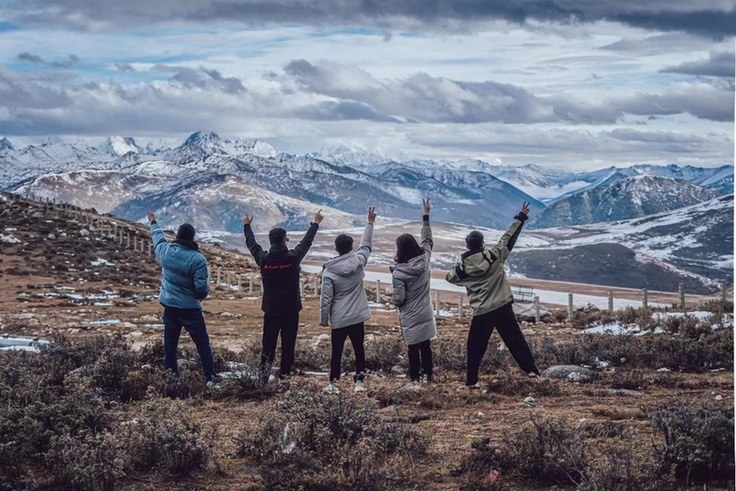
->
<box><xmin>0</xmin><ymin>131</ymin><xmax>733</xmax><ymax>232</ymax></box>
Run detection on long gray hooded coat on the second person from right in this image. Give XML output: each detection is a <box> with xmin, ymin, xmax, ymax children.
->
<box><xmin>391</xmin><ymin>216</ymin><xmax>437</xmax><ymax>345</ymax></box>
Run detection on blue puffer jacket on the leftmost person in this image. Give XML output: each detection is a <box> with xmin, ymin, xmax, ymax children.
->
<box><xmin>151</xmin><ymin>222</ymin><xmax>210</xmax><ymax>309</ymax></box>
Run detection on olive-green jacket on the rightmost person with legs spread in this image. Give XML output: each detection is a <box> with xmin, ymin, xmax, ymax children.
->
<box><xmin>445</xmin><ymin>214</ymin><xmax>527</xmax><ymax>315</ymax></box>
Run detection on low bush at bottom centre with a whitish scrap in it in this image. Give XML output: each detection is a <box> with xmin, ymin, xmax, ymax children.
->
<box><xmin>238</xmin><ymin>388</ymin><xmax>427</xmax><ymax>490</ymax></box>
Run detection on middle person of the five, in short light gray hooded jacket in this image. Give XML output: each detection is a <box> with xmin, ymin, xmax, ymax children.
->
<box><xmin>319</xmin><ymin>208</ymin><xmax>376</xmax><ymax>392</ymax></box>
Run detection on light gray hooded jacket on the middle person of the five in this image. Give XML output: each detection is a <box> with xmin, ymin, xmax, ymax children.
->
<box><xmin>319</xmin><ymin>223</ymin><xmax>373</xmax><ymax>329</ymax></box>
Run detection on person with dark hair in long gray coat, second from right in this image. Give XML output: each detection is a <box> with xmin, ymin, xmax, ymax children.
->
<box><xmin>390</xmin><ymin>199</ymin><xmax>437</xmax><ymax>388</ymax></box>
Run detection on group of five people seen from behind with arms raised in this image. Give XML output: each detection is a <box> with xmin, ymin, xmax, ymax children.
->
<box><xmin>148</xmin><ymin>199</ymin><xmax>539</xmax><ymax>392</ymax></box>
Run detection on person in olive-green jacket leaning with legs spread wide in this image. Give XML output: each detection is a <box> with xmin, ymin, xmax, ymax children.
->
<box><xmin>446</xmin><ymin>202</ymin><xmax>539</xmax><ymax>388</ymax></box>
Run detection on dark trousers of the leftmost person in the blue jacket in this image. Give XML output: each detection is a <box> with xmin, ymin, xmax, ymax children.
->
<box><xmin>164</xmin><ymin>306</ymin><xmax>215</xmax><ymax>380</ymax></box>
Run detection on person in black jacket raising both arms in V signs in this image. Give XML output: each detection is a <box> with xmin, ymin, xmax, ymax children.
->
<box><xmin>243</xmin><ymin>210</ymin><xmax>323</xmax><ymax>382</ymax></box>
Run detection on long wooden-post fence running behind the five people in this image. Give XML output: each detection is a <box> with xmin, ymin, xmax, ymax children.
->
<box><xmin>1</xmin><ymin>192</ymin><xmax>728</xmax><ymax>322</ymax></box>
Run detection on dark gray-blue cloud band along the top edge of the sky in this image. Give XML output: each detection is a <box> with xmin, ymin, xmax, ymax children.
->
<box><xmin>7</xmin><ymin>0</ymin><xmax>736</xmax><ymax>38</ymax></box>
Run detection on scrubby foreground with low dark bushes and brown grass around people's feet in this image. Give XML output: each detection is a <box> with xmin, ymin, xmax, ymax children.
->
<box><xmin>0</xmin><ymin>302</ymin><xmax>734</xmax><ymax>490</ymax></box>
